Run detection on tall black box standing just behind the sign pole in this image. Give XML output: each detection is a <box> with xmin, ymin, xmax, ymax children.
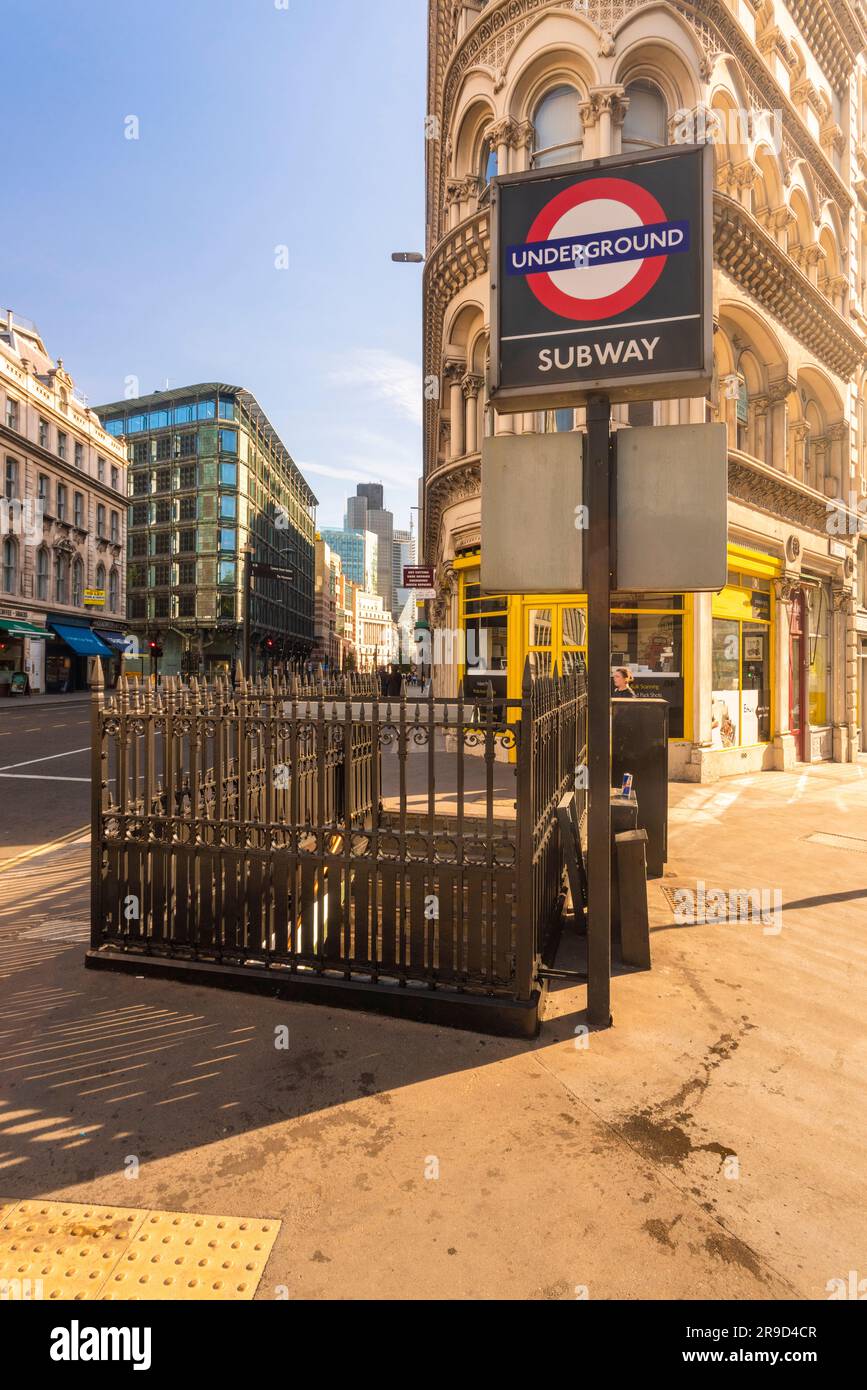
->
<box><xmin>611</xmin><ymin>698</ymin><xmax>668</xmax><ymax>878</ymax></box>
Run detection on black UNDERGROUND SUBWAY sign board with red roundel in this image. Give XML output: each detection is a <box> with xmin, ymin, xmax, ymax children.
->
<box><xmin>488</xmin><ymin>145</ymin><xmax>713</xmax><ymax>413</ymax></box>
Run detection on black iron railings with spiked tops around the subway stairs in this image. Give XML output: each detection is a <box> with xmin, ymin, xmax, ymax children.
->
<box><xmin>92</xmin><ymin>661</ymin><xmax>586</xmax><ymax>1001</ymax></box>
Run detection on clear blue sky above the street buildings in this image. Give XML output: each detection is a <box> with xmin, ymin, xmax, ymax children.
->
<box><xmin>0</xmin><ymin>0</ymin><xmax>427</xmax><ymax>525</ymax></box>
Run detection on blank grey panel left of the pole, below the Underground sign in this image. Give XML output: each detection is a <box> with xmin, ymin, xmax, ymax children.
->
<box><xmin>481</xmin><ymin>432</ymin><xmax>584</xmax><ymax>594</ymax></box>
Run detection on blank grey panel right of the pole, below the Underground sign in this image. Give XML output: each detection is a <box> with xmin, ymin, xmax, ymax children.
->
<box><xmin>616</xmin><ymin>425</ymin><xmax>728</xmax><ymax>594</ymax></box>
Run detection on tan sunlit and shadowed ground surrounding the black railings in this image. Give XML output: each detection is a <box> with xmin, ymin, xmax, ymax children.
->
<box><xmin>0</xmin><ymin>705</ymin><xmax>867</xmax><ymax>1300</ymax></box>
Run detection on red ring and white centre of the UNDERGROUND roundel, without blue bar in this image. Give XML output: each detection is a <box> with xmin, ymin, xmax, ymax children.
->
<box><xmin>527</xmin><ymin>178</ymin><xmax>668</xmax><ymax>322</ymax></box>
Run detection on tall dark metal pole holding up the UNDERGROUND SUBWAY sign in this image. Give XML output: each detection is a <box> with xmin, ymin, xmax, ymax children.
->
<box><xmin>586</xmin><ymin>396</ymin><xmax>613</xmax><ymax>1027</ymax></box>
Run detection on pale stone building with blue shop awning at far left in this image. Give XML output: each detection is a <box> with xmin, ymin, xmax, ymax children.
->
<box><xmin>0</xmin><ymin>309</ymin><xmax>126</xmax><ymax>695</ymax></box>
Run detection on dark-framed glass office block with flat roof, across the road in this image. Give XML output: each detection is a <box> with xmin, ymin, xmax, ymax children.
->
<box><xmin>97</xmin><ymin>382</ymin><xmax>317</xmax><ymax>678</ymax></box>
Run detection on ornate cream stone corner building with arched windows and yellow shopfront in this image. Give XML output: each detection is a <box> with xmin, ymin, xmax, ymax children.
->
<box><xmin>422</xmin><ymin>0</ymin><xmax>867</xmax><ymax>781</ymax></box>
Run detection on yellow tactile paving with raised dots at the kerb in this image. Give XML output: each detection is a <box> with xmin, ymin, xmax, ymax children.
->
<box><xmin>0</xmin><ymin>1200</ymin><xmax>281</xmax><ymax>1301</ymax></box>
